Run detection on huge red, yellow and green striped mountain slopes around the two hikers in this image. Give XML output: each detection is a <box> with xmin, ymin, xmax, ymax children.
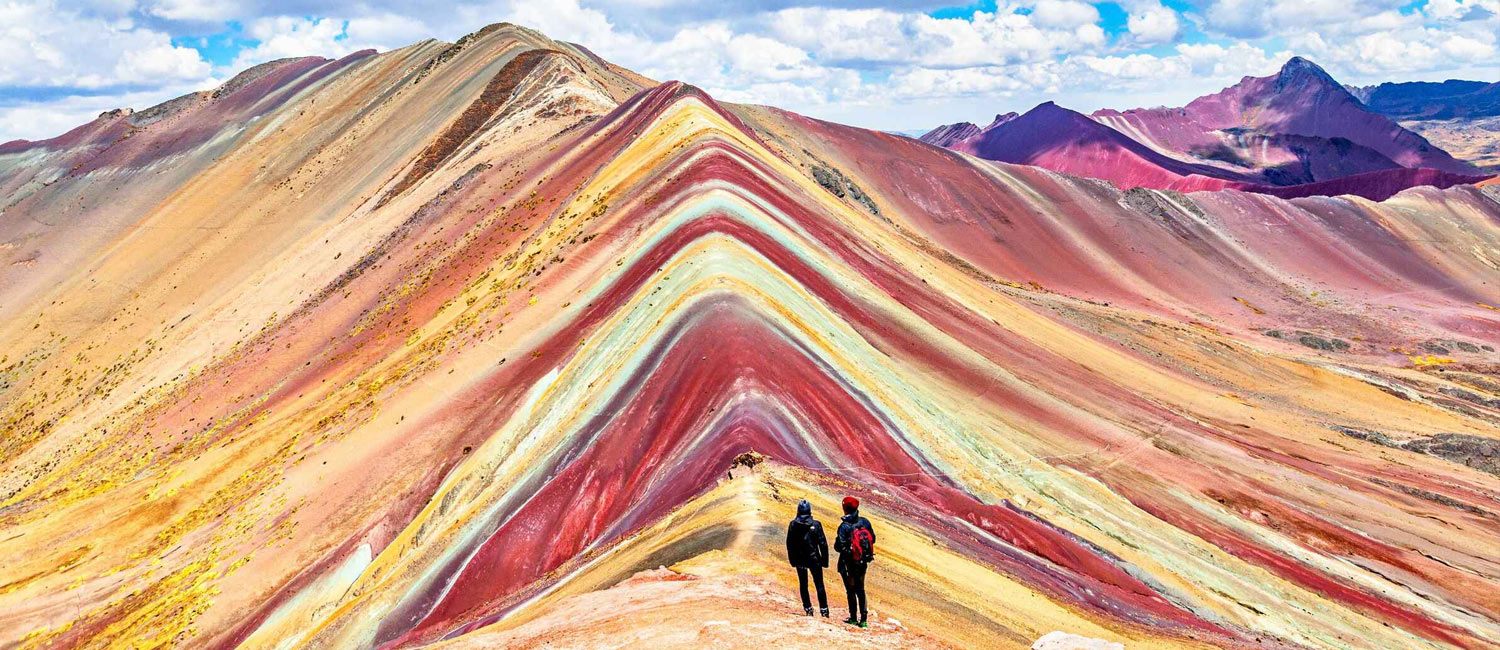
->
<box><xmin>0</xmin><ymin>20</ymin><xmax>1500</xmax><ymax>648</ymax></box>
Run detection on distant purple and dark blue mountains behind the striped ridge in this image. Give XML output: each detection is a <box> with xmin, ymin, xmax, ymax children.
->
<box><xmin>921</xmin><ymin>57</ymin><xmax>1494</xmax><ymax>200</ymax></box>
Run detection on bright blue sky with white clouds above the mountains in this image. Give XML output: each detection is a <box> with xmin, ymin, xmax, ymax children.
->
<box><xmin>0</xmin><ymin>0</ymin><xmax>1500</xmax><ymax>141</ymax></box>
